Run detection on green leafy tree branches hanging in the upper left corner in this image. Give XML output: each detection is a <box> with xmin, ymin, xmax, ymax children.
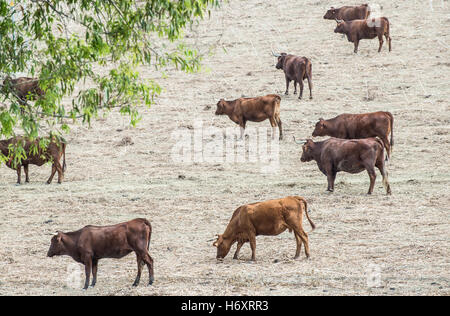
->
<box><xmin>0</xmin><ymin>0</ymin><xmax>219</xmax><ymax>145</ymax></box>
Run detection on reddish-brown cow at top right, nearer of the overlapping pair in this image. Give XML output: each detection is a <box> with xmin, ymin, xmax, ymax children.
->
<box><xmin>334</xmin><ymin>17</ymin><xmax>392</xmax><ymax>53</ymax></box>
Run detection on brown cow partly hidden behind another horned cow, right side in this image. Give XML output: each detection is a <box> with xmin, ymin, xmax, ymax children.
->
<box><xmin>312</xmin><ymin>112</ymin><xmax>394</xmax><ymax>159</ymax></box>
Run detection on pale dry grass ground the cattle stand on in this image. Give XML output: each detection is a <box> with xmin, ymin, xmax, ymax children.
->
<box><xmin>0</xmin><ymin>0</ymin><xmax>450</xmax><ymax>295</ymax></box>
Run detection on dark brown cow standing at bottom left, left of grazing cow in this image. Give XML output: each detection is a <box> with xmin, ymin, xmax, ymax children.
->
<box><xmin>47</xmin><ymin>218</ymin><xmax>154</xmax><ymax>290</ymax></box>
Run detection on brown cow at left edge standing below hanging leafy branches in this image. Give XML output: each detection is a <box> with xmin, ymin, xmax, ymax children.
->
<box><xmin>0</xmin><ymin>137</ymin><xmax>66</xmax><ymax>184</ymax></box>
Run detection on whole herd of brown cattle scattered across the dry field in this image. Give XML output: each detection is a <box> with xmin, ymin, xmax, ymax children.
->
<box><xmin>0</xmin><ymin>5</ymin><xmax>394</xmax><ymax>289</ymax></box>
